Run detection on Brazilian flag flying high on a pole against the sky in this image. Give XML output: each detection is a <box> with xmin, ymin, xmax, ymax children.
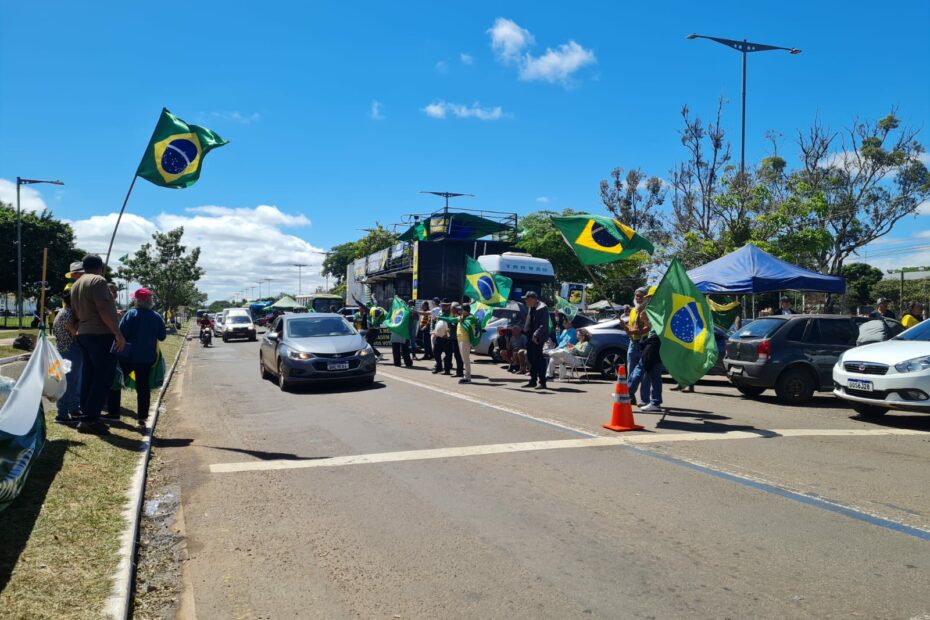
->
<box><xmin>136</xmin><ymin>108</ymin><xmax>228</xmax><ymax>189</ymax></box>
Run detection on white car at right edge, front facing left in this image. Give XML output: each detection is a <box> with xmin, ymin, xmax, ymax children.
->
<box><xmin>833</xmin><ymin>320</ymin><xmax>930</xmax><ymax>417</ymax></box>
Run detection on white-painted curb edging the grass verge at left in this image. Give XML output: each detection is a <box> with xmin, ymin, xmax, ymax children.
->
<box><xmin>103</xmin><ymin>327</ymin><xmax>191</xmax><ymax>620</ymax></box>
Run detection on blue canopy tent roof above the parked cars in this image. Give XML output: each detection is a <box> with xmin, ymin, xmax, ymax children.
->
<box><xmin>688</xmin><ymin>243</ymin><xmax>846</xmax><ymax>295</ymax></box>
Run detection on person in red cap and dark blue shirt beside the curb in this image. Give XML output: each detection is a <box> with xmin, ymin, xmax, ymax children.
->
<box><xmin>110</xmin><ymin>288</ymin><xmax>167</xmax><ymax>425</ymax></box>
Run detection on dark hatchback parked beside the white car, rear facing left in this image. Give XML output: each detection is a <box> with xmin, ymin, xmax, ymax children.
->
<box><xmin>724</xmin><ymin>314</ymin><xmax>867</xmax><ymax>404</ymax></box>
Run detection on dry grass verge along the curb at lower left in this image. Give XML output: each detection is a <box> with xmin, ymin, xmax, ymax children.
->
<box><xmin>0</xmin><ymin>327</ymin><xmax>186</xmax><ymax>619</ymax></box>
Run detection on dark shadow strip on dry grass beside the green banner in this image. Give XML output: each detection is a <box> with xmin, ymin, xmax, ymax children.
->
<box><xmin>0</xmin><ymin>439</ymin><xmax>84</xmax><ymax>592</ymax></box>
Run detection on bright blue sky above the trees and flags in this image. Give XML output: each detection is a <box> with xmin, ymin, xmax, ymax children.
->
<box><xmin>0</xmin><ymin>1</ymin><xmax>930</xmax><ymax>295</ymax></box>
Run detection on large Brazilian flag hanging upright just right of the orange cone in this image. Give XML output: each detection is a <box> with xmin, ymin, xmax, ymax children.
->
<box><xmin>646</xmin><ymin>258</ymin><xmax>718</xmax><ymax>385</ymax></box>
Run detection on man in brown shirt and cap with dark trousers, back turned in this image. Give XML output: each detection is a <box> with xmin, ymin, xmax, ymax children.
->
<box><xmin>71</xmin><ymin>254</ymin><xmax>126</xmax><ymax>435</ymax></box>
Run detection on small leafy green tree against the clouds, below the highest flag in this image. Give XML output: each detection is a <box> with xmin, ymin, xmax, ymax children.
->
<box><xmin>119</xmin><ymin>227</ymin><xmax>206</xmax><ymax>308</ymax></box>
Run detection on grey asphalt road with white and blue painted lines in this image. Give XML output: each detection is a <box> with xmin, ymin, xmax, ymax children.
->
<box><xmin>156</xmin><ymin>342</ymin><xmax>930</xmax><ymax>618</ymax></box>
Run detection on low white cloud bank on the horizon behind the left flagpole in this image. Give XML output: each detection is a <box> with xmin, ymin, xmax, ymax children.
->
<box><xmin>71</xmin><ymin>205</ymin><xmax>325</xmax><ymax>300</ymax></box>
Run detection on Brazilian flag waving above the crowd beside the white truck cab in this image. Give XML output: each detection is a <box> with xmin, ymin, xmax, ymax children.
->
<box><xmin>552</xmin><ymin>214</ymin><xmax>655</xmax><ymax>265</ymax></box>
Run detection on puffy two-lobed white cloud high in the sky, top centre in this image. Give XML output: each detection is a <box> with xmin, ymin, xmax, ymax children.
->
<box><xmin>488</xmin><ymin>17</ymin><xmax>597</xmax><ymax>85</ymax></box>
